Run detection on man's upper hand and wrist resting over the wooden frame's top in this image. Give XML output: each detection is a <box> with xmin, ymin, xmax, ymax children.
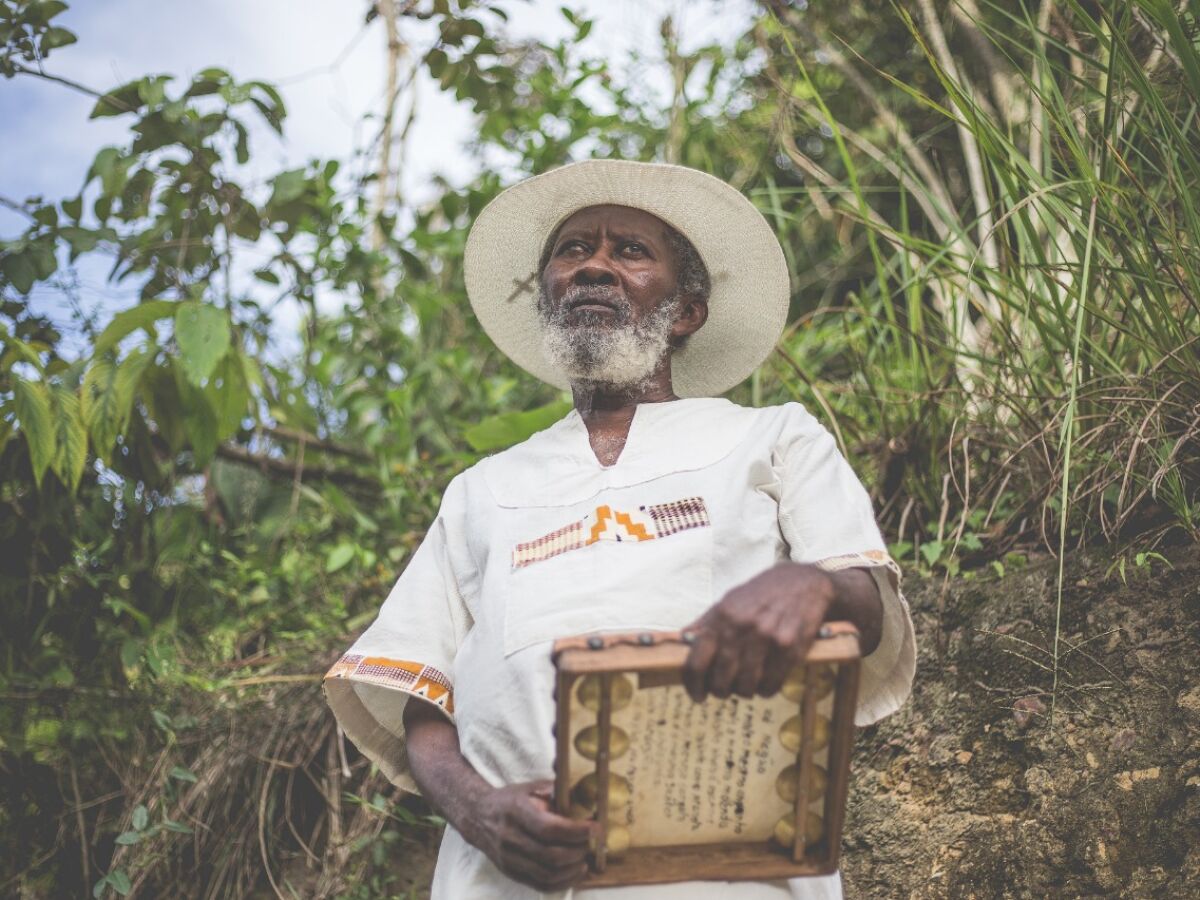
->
<box><xmin>684</xmin><ymin>563</ymin><xmax>882</xmax><ymax>701</ymax></box>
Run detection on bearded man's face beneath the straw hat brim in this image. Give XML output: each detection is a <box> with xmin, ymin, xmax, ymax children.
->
<box><xmin>538</xmin><ymin>205</ymin><xmax>695</xmax><ymax>385</ymax></box>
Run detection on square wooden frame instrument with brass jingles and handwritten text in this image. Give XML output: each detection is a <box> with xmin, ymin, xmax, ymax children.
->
<box><xmin>553</xmin><ymin>623</ymin><xmax>860</xmax><ymax>887</ymax></box>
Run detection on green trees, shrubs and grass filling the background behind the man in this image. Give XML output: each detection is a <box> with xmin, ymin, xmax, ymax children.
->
<box><xmin>0</xmin><ymin>0</ymin><xmax>1200</xmax><ymax>898</ymax></box>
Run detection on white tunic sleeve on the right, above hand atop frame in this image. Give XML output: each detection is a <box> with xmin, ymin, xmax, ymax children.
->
<box><xmin>773</xmin><ymin>404</ymin><xmax>917</xmax><ymax>725</ymax></box>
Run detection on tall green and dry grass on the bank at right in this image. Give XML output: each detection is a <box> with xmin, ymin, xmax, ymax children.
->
<box><xmin>766</xmin><ymin>0</ymin><xmax>1200</xmax><ymax>563</ymax></box>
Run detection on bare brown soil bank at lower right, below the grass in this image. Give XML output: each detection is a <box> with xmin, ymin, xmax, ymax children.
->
<box><xmin>842</xmin><ymin>547</ymin><xmax>1200</xmax><ymax>899</ymax></box>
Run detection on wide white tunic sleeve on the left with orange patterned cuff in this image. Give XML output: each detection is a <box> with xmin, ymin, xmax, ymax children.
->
<box><xmin>324</xmin><ymin>475</ymin><xmax>472</xmax><ymax>793</ymax></box>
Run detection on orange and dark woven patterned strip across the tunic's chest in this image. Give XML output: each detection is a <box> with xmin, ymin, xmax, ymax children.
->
<box><xmin>512</xmin><ymin>497</ymin><xmax>710</xmax><ymax>569</ymax></box>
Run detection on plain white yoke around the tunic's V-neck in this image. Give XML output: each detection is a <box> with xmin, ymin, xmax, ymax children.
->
<box><xmin>480</xmin><ymin>397</ymin><xmax>760</xmax><ymax>508</ymax></box>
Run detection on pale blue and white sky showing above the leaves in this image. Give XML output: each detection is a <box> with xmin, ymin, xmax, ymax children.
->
<box><xmin>0</xmin><ymin>0</ymin><xmax>754</xmax><ymax>352</ymax></box>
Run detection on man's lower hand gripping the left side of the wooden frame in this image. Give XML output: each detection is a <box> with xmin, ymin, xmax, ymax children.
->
<box><xmin>463</xmin><ymin>781</ymin><xmax>595</xmax><ymax>892</ymax></box>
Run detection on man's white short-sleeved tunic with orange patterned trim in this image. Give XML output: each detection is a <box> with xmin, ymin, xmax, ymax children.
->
<box><xmin>325</xmin><ymin>398</ymin><xmax>916</xmax><ymax>900</ymax></box>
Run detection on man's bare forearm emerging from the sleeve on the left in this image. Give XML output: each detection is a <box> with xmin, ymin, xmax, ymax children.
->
<box><xmin>404</xmin><ymin>700</ymin><xmax>492</xmax><ymax>846</ymax></box>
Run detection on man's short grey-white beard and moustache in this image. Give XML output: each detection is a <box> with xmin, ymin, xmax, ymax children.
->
<box><xmin>538</xmin><ymin>286</ymin><xmax>679</xmax><ymax>388</ymax></box>
